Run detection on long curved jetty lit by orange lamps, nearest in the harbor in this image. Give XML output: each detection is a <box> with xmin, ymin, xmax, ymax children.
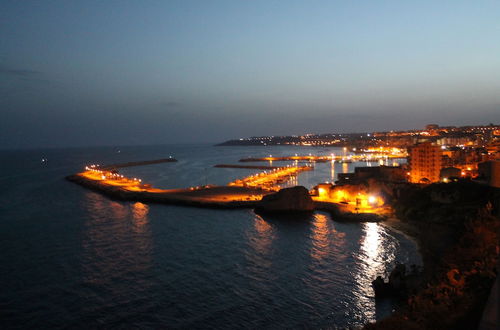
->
<box><xmin>66</xmin><ymin>158</ymin><xmax>382</xmax><ymax>221</ymax></box>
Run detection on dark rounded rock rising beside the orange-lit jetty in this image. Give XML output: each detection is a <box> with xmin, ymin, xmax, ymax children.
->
<box><xmin>255</xmin><ymin>186</ymin><xmax>314</xmax><ymax>213</ymax></box>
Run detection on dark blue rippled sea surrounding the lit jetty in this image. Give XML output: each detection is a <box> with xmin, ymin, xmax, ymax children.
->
<box><xmin>0</xmin><ymin>145</ymin><xmax>421</xmax><ymax>329</ymax></box>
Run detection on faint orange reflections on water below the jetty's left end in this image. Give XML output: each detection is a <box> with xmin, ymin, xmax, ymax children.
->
<box><xmin>81</xmin><ymin>192</ymin><xmax>152</xmax><ymax>290</ymax></box>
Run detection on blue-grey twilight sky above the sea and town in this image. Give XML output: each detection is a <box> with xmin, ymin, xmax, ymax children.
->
<box><xmin>0</xmin><ymin>0</ymin><xmax>500</xmax><ymax>148</ymax></box>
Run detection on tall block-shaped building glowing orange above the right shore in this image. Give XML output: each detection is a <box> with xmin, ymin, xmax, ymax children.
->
<box><xmin>410</xmin><ymin>142</ymin><xmax>442</xmax><ymax>183</ymax></box>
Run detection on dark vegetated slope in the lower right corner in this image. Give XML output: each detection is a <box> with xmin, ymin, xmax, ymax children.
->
<box><xmin>365</xmin><ymin>181</ymin><xmax>500</xmax><ymax>329</ymax></box>
